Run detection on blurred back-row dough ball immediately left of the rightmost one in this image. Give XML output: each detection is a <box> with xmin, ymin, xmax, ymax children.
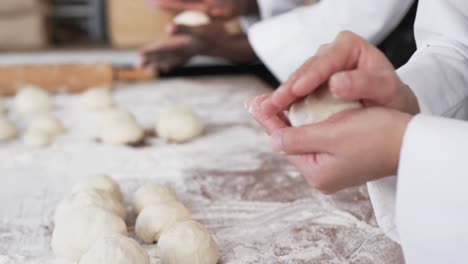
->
<box><xmin>99</xmin><ymin>109</ymin><xmax>145</xmax><ymax>145</ymax></box>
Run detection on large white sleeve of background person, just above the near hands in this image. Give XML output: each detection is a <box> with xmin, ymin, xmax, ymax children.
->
<box><xmin>249</xmin><ymin>0</ymin><xmax>413</xmax><ymax>81</ymax></box>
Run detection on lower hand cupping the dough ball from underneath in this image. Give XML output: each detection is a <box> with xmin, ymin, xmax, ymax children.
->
<box><xmin>247</xmin><ymin>96</ymin><xmax>412</xmax><ymax>193</ymax></box>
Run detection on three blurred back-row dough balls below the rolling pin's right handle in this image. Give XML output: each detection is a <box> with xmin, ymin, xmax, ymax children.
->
<box><xmin>82</xmin><ymin>88</ymin><xmax>205</xmax><ymax>144</ymax></box>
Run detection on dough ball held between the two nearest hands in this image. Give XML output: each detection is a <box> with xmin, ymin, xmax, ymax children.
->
<box><xmin>288</xmin><ymin>86</ymin><xmax>362</xmax><ymax>127</ymax></box>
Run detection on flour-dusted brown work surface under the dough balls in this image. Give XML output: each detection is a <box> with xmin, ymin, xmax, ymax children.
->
<box><xmin>0</xmin><ymin>76</ymin><xmax>403</xmax><ymax>264</ymax></box>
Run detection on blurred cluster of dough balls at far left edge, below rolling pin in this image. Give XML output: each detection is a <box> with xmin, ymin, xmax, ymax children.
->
<box><xmin>0</xmin><ymin>86</ymin><xmax>65</xmax><ymax>147</ymax></box>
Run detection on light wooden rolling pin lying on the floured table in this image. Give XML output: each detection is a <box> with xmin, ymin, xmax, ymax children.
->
<box><xmin>0</xmin><ymin>63</ymin><xmax>157</xmax><ymax>95</ymax></box>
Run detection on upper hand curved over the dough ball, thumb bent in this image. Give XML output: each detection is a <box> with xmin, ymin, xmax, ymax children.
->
<box><xmin>261</xmin><ymin>32</ymin><xmax>419</xmax><ymax>116</ymax></box>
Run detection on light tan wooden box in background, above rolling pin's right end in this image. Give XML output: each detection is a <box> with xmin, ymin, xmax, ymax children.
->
<box><xmin>107</xmin><ymin>0</ymin><xmax>174</xmax><ymax>47</ymax></box>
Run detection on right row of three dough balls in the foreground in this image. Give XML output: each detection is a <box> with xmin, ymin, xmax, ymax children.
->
<box><xmin>132</xmin><ymin>184</ymin><xmax>220</xmax><ymax>264</ymax></box>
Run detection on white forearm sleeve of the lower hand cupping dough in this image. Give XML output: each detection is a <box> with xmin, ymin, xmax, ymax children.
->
<box><xmin>396</xmin><ymin>115</ymin><xmax>468</xmax><ymax>264</ymax></box>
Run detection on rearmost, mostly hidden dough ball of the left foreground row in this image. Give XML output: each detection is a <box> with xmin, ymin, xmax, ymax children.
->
<box><xmin>72</xmin><ymin>175</ymin><xmax>123</xmax><ymax>202</ymax></box>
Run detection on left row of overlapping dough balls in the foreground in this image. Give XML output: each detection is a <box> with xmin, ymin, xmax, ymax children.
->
<box><xmin>51</xmin><ymin>175</ymin><xmax>150</xmax><ymax>264</ymax></box>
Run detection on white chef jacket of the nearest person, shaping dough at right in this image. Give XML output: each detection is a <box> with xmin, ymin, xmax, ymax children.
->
<box><xmin>368</xmin><ymin>0</ymin><xmax>468</xmax><ymax>252</ymax></box>
